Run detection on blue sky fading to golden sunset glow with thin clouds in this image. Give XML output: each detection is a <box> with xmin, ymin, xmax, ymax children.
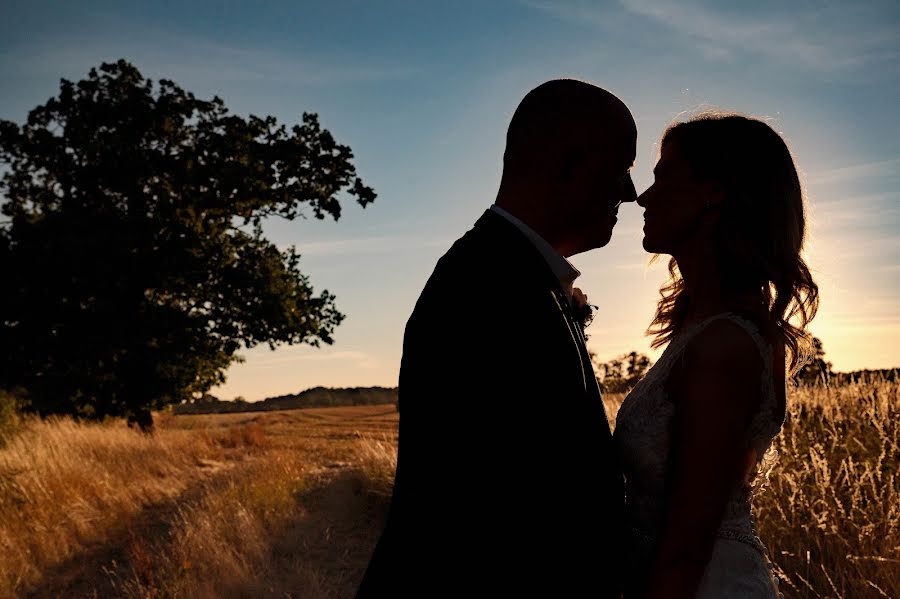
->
<box><xmin>0</xmin><ymin>0</ymin><xmax>900</xmax><ymax>401</ymax></box>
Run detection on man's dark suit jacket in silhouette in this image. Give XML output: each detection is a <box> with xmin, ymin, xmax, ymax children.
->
<box><xmin>357</xmin><ymin>211</ymin><xmax>624</xmax><ymax>598</ymax></box>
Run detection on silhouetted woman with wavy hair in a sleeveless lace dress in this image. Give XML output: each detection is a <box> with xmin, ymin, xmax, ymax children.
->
<box><xmin>614</xmin><ymin>113</ymin><xmax>818</xmax><ymax>599</ymax></box>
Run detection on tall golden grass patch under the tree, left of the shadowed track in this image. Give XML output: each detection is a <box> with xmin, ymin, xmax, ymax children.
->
<box><xmin>0</xmin><ymin>419</ymin><xmax>220</xmax><ymax>596</ymax></box>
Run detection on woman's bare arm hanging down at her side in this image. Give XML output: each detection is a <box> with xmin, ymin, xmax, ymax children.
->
<box><xmin>648</xmin><ymin>320</ymin><xmax>762</xmax><ymax>599</ymax></box>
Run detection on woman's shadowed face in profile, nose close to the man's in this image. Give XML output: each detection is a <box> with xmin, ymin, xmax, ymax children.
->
<box><xmin>637</xmin><ymin>140</ymin><xmax>720</xmax><ymax>254</ymax></box>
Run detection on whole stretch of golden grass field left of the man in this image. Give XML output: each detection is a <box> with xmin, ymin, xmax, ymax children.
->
<box><xmin>0</xmin><ymin>406</ymin><xmax>397</xmax><ymax>597</ymax></box>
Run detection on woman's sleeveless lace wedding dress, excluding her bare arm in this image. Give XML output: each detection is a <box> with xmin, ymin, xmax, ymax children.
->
<box><xmin>613</xmin><ymin>313</ymin><xmax>781</xmax><ymax>599</ymax></box>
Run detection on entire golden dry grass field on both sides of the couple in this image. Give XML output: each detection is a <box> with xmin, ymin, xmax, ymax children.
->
<box><xmin>0</xmin><ymin>381</ymin><xmax>900</xmax><ymax>599</ymax></box>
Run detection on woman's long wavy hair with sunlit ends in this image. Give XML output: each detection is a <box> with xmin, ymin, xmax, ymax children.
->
<box><xmin>647</xmin><ymin>112</ymin><xmax>819</xmax><ymax>373</ymax></box>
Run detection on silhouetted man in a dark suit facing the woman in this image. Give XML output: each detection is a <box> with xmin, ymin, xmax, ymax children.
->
<box><xmin>357</xmin><ymin>79</ymin><xmax>637</xmax><ymax>598</ymax></box>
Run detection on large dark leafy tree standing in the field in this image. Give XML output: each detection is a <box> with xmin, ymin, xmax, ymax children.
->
<box><xmin>0</xmin><ymin>60</ymin><xmax>375</xmax><ymax>428</ymax></box>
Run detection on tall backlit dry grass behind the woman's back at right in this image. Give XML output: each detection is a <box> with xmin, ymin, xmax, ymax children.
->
<box><xmin>755</xmin><ymin>380</ymin><xmax>900</xmax><ymax>599</ymax></box>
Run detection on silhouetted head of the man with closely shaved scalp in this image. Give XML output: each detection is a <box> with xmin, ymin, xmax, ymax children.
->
<box><xmin>496</xmin><ymin>79</ymin><xmax>637</xmax><ymax>256</ymax></box>
